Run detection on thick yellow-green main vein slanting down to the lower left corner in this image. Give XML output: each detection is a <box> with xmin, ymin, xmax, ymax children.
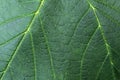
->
<box><xmin>0</xmin><ymin>0</ymin><xmax>44</xmax><ymax>80</ymax></box>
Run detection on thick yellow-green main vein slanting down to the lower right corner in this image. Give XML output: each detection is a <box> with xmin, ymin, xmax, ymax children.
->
<box><xmin>88</xmin><ymin>1</ymin><xmax>115</xmax><ymax>80</ymax></box>
